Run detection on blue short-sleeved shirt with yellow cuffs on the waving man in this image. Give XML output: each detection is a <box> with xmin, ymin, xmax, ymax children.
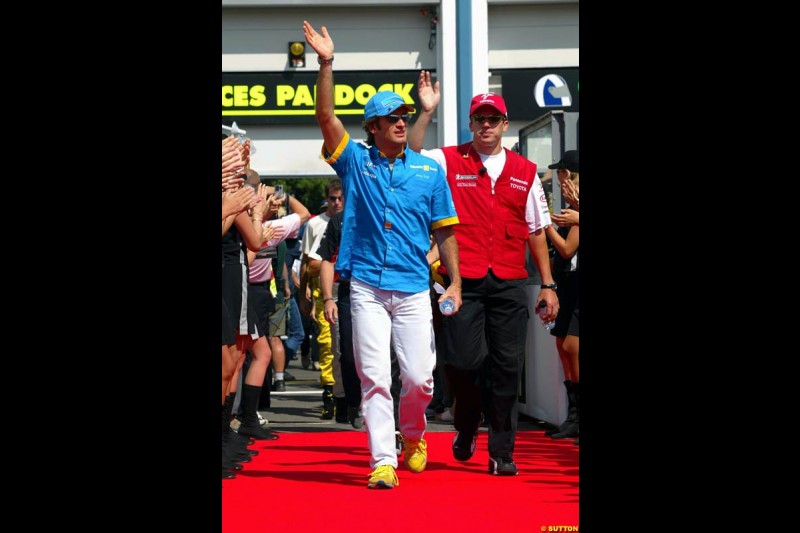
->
<box><xmin>322</xmin><ymin>133</ymin><xmax>458</xmax><ymax>293</ymax></box>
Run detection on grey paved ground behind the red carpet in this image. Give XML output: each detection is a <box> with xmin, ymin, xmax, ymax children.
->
<box><xmin>261</xmin><ymin>359</ymin><xmax>549</xmax><ymax>432</ymax></box>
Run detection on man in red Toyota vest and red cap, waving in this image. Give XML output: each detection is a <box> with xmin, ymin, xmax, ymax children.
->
<box><xmin>408</xmin><ymin>71</ymin><xmax>558</xmax><ymax>476</ymax></box>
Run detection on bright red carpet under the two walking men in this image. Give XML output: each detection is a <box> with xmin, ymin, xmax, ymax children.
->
<box><xmin>222</xmin><ymin>430</ymin><xmax>578</xmax><ymax>533</ymax></box>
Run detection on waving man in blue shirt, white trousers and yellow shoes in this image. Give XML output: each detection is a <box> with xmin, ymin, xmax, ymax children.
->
<box><xmin>303</xmin><ymin>21</ymin><xmax>461</xmax><ymax>489</ymax></box>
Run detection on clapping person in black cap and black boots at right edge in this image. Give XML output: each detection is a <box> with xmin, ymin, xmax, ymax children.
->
<box><xmin>544</xmin><ymin>150</ymin><xmax>580</xmax><ymax>444</ymax></box>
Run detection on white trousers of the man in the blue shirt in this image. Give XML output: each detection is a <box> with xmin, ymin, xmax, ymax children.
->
<box><xmin>350</xmin><ymin>278</ymin><xmax>436</xmax><ymax>469</ymax></box>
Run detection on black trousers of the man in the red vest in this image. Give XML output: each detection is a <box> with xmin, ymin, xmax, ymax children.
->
<box><xmin>443</xmin><ymin>270</ymin><xmax>529</xmax><ymax>458</ymax></box>
